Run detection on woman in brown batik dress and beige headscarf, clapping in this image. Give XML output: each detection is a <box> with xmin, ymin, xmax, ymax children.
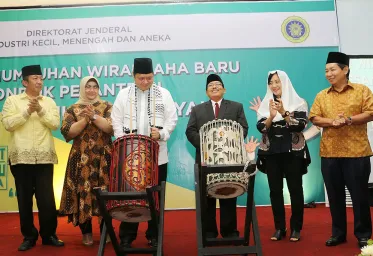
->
<box><xmin>59</xmin><ymin>76</ymin><xmax>113</xmax><ymax>245</ymax></box>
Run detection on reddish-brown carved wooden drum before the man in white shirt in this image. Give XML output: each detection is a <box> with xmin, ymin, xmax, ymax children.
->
<box><xmin>107</xmin><ymin>134</ymin><xmax>159</xmax><ymax>222</ymax></box>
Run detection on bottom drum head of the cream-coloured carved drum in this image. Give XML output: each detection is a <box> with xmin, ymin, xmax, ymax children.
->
<box><xmin>207</xmin><ymin>181</ymin><xmax>247</xmax><ymax>199</ymax></box>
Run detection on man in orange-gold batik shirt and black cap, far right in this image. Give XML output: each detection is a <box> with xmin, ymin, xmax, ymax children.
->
<box><xmin>309</xmin><ymin>52</ymin><xmax>373</xmax><ymax>247</ymax></box>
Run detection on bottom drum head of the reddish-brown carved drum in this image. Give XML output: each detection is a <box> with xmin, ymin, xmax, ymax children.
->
<box><xmin>109</xmin><ymin>205</ymin><xmax>151</xmax><ymax>222</ymax></box>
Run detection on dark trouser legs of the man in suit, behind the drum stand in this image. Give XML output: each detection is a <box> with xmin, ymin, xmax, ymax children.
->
<box><xmin>204</xmin><ymin>197</ymin><xmax>238</xmax><ymax>237</ymax></box>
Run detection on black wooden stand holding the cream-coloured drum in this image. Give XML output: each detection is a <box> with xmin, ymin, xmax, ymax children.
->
<box><xmin>194</xmin><ymin>162</ymin><xmax>262</xmax><ymax>256</ymax></box>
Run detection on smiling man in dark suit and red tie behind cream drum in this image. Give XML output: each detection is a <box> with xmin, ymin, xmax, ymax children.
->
<box><xmin>185</xmin><ymin>74</ymin><xmax>248</xmax><ymax>238</ymax></box>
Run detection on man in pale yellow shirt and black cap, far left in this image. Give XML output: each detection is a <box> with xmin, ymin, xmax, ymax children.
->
<box><xmin>2</xmin><ymin>65</ymin><xmax>64</xmax><ymax>251</ymax></box>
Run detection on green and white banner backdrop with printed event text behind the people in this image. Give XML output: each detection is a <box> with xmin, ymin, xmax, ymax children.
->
<box><xmin>0</xmin><ymin>1</ymin><xmax>339</xmax><ymax>211</ymax></box>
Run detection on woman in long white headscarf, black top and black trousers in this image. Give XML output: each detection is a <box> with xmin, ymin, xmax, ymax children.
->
<box><xmin>257</xmin><ymin>70</ymin><xmax>311</xmax><ymax>242</ymax></box>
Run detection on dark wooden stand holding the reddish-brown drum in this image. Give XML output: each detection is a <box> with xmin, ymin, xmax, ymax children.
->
<box><xmin>94</xmin><ymin>181</ymin><xmax>166</xmax><ymax>256</ymax></box>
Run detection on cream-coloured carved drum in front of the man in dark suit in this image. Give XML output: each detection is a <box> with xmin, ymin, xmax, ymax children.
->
<box><xmin>199</xmin><ymin>119</ymin><xmax>250</xmax><ymax>199</ymax></box>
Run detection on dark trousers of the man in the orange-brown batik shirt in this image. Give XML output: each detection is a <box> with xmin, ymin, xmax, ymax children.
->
<box><xmin>321</xmin><ymin>157</ymin><xmax>372</xmax><ymax>239</ymax></box>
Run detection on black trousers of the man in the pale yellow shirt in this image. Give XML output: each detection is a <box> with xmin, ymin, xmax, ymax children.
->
<box><xmin>10</xmin><ymin>164</ymin><xmax>57</xmax><ymax>241</ymax></box>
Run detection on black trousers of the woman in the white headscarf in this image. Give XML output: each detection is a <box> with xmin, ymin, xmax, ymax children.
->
<box><xmin>266</xmin><ymin>153</ymin><xmax>304</xmax><ymax>231</ymax></box>
